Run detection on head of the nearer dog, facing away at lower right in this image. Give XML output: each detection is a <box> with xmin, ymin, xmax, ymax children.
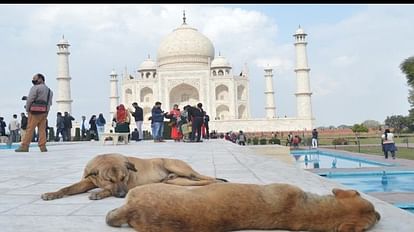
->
<box><xmin>332</xmin><ymin>188</ymin><xmax>381</xmax><ymax>232</ymax></box>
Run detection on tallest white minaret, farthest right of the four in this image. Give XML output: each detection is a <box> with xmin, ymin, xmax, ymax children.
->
<box><xmin>293</xmin><ymin>25</ymin><xmax>312</xmax><ymax>119</ymax></box>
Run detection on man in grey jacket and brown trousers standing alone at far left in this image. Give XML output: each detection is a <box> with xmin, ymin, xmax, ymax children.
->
<box><xmin>15</xmin><ymin>73</ymin><xmax>53</xmax><ymax>152</ymax></box>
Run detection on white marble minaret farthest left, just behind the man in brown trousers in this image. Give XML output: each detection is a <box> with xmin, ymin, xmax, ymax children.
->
<box><xmin>56</xmin><ymin>36</ymin><xmax>73</xmax><ymax>114</ymax></box>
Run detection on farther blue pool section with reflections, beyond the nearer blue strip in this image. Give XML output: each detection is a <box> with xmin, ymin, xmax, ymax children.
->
<box><xmin>291</xmin><ymin>150</ymin><xmax>393</xmax><ymax>169</ymax></box>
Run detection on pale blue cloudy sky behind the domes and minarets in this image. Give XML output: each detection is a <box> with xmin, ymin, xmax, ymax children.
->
<box><xmin>0</xmin><ymin>4</ymin><xmax>414</xmax><ymax>127</ymax></box>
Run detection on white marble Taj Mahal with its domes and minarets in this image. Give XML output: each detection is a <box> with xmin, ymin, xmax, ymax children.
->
<box><xmin>56</xmin><ymin>14</ymin><xmax>315</xmax><ymax>132</ymax></box>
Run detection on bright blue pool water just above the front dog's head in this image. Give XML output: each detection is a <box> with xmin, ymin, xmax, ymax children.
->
<box><xmin>319</xmin><ymin>171</ymin><xmax>414</xmax><ymax>193</ymax></box>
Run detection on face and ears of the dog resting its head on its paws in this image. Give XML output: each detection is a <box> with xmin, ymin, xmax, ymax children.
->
<box><xmin>85</xmin><ymin>161</ymin><xmax>138</xmax><ymax>197</ymax></box>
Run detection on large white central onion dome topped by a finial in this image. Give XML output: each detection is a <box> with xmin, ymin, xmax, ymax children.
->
<box><xmin>157</xmin><ymin>23</ymin><xmax>214</xmax><ymax>67</ymax></box>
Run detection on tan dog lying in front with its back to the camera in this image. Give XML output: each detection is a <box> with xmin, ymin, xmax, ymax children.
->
<box><xmin>106</xmin><ymin>183</ymin><xmax>380</xmax><ymax>232</ymax></box>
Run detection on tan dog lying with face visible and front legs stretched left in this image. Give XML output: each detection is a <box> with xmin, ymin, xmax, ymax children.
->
<box><xmin>41</xmin><ymin>154</ymin><xmax>226</xmax><ymax>200</ymax></box>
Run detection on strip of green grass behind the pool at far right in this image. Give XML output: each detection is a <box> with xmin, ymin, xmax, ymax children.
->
<box><xmin>336</xmin><ymin>146</ymin><xmax>414</xmax><ymax>160</ymax></box>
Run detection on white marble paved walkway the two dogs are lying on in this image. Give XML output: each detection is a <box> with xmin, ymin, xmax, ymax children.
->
<box><xmin>0</xmin><ymin>140</ymin><xmax>414</xmax><ymax>232</ymax></box>
